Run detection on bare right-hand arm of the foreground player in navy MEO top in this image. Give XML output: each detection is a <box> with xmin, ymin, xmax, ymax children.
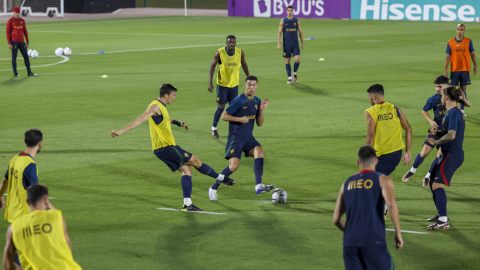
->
<box><xmin>380</xmin><ymin>174</ymin><xmax>403</xmax><ymax>249</ymax></box>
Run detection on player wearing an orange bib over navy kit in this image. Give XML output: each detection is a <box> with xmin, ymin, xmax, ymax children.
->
<box><xmin>444</xmin><ymin>24</ymin><xmax>477</xmax><ymax>116</ymax></box>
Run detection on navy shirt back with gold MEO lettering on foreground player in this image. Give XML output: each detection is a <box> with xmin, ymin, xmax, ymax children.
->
<box><xmin>343</xmin><ymin>170</ymin><xmax>386</xmax><ymax>247</ymax></box>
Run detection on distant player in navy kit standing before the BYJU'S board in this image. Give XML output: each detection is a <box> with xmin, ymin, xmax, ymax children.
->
<box><xmin>277</xmin><ymin>6</ymin><xmax>305</xmax><ymax>83</ymax></box>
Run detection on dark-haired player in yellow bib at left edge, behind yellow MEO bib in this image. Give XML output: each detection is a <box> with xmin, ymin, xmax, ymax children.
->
<box><xmin>0</xmin><ymin>129</ymin><xmax>43</xmax><ymax>223</ymax></box>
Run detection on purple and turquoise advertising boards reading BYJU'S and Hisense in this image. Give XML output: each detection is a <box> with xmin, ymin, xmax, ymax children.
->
<box><xmin>228</xmin><ymin>0</ymin><xmax>480</xmax><ymax>22</ymax></box>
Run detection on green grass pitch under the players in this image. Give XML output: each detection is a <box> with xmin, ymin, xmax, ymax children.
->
<box><xmin>0</xmin><ymin>17</ymin><xmax>480</xmax><ymax>269</ymax></box>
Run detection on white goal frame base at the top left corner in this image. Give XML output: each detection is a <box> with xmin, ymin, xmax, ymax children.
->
<box><xmin>19</xmin><ymin>0</ymin><xmax>63</xmax><ymax>17</ymax></box>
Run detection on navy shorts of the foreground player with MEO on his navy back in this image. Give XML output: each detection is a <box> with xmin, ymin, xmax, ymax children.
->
<box><xmin>343</xmin><ymin>247</ymin><xmax>395</xmax><ymax>270</ymax></box>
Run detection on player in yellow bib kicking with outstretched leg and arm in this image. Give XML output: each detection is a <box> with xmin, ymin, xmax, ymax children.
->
<box><xmin>110</xmin><ymin>83</ymin><xmax>235</xmax><ymax>212</ymax></box>
